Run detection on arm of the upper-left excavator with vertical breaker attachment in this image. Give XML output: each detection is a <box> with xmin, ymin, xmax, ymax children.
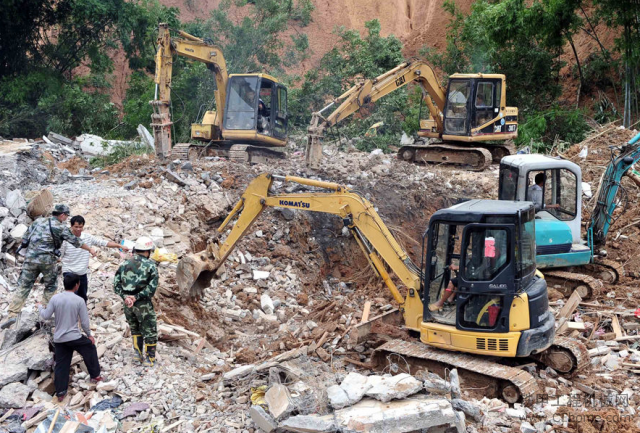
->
<box><xmin>150</xmin><ymin>24</ymin><xmax>229</xmax><ymax>158</ymax></box>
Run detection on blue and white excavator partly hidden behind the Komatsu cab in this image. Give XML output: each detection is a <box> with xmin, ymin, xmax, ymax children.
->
<box><xmin>498</xmin><ymin>129</ymin><xmax>640</xmax><ymax>298</ymax></box>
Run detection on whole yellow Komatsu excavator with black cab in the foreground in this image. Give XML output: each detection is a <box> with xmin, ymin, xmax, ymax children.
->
<box><xmin>176</xmin><ymin>174</ymin><xmax>589</xmax><ymax>403</ymax></box>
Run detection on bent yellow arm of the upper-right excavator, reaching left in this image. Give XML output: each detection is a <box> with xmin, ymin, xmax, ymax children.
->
<box><xmin>306</xmin><ymin>61</ymin><xmax>446</xmax><ymax>168</ymax></box>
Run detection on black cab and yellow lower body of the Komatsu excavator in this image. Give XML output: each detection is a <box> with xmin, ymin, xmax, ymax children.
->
<box><xmin>420</xmin><ymin>200</ymin><xmax>554</xmax><ymax>356</ymax></box>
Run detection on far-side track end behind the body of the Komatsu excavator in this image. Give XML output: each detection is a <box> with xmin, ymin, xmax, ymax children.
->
<box><xmin>531</xmin><ymin>337</ymin><xmax>589</xmax><ymax>375</ymax></box>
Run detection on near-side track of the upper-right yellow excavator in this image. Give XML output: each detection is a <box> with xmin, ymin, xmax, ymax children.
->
<box><xmin>398</xmin><ymin>143</ymin><xmax>493</xmax><ymax>171</ymax></box>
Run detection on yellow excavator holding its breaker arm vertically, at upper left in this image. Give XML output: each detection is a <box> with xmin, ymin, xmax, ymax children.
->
<box><xmin>150</xmin><ymin>24</ymin><xmax>287</xmax><ymax>163</ymax></box>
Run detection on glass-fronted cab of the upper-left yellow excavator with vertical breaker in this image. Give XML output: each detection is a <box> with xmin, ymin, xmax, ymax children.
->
<box><xmin>222</xmin><ymin>74</ymin><xmax>287</xmax><ymax>144</ymax></box>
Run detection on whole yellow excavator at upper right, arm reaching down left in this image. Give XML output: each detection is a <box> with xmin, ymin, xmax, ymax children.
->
<box><xmin>306</xmin><ymin>60</ymin><xmax>518</xmax><ymax>171</ymax></box>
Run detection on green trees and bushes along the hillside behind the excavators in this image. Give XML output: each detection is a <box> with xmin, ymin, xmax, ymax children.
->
<box><xmin>0</xmin><ymin>0</ymin><xmax>640</xmax><ymax>154</ymax></box>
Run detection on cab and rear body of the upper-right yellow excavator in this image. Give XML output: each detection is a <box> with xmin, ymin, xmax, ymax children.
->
<box><xmin>443</xmin><ymin>74</ymin><xmax>518</xmax><ymax>141</ymax></box>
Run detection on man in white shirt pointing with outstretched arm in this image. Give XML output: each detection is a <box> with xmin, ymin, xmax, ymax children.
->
<box><xmin>60</xmin><ymin>215</ymin><xmax>129</xmax><ymax>303</ymax></box>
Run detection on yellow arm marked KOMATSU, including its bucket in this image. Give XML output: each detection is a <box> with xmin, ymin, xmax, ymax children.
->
<box><xmin>177</xmin><ymin>174</ymin><xmax>422</xmax><ymax>330</ymax></box>
